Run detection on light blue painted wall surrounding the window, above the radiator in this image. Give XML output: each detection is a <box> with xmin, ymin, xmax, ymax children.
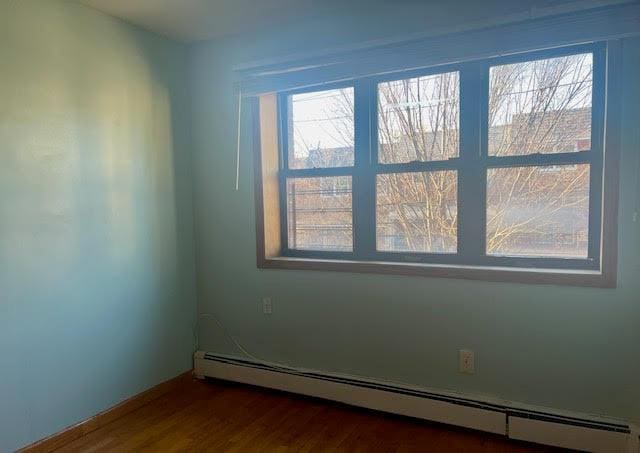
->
<box><xmin>192</xmin><ymin>1</ymin><xmax>640</xmax><ymax>420</ymax></box>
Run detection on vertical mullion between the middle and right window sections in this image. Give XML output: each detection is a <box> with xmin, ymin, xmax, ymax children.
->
<box><xmin>458</xmin><ymin>62</ymin><xmax>489</xmax><ymax>264</ymax></box>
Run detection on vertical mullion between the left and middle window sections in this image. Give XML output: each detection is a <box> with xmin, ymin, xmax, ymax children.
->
<box><xmin>352</xmin><ymin>80</ymin><xmax>376</xmax><ymax>259</ymax></box>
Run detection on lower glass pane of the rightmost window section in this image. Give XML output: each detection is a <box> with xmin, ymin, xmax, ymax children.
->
<box><xmin>487</xmin><ymin>164</ymin><xmax>589</xmax><ymax>258</ymax></box>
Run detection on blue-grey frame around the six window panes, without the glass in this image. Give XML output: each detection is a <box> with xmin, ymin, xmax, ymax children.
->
<box><xmin>258</xmin><ymin>41</ymin><xmax>619</xmax><ymax>286</ymax></box>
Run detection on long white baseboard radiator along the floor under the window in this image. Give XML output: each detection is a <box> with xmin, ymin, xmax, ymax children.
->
<box><xmin>194</xmin><ymin>351</ymin><xmax>640</xmax><ymax>453</ymax></box>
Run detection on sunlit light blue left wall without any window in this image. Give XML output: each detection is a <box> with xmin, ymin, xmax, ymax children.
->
<box><xmin>0</xmin><ymin>0</ymin><xmax>196</xmax><ymax>452</ymax></box>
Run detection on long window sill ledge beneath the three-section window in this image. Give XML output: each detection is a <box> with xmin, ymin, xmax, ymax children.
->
<box><xmin>258</xmin><ymin>257</ymin><xmax>616</xmax><ymax>288</ymax></box>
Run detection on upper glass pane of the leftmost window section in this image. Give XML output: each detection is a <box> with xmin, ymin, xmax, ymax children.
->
<box><xmin>288</xmin><ymin>88</ymin><xmax>354</xmax><ymax>168</ymax></box>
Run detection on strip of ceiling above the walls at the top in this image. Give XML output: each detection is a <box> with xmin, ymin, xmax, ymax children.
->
<box><xmin>76</xmin><ymin>0</ymin><xmax>629</xmax><ymax>41</ymax></box>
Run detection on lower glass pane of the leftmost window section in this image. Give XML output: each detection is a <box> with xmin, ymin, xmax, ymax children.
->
<box><xmin>287</xmin><ymin>176</ymin><xmax>353</xmax><ymax>251</ymax></box>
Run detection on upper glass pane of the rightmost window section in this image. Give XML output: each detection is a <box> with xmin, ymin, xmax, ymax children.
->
<box><xmin>489</xmin><ymin>53</ymin><xmax>593</xmax><ymax>156</ymax></box>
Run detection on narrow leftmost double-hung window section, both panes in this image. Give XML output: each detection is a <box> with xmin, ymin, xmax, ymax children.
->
<box><xmin>282</xmin><ymin>87</ymin><xmax>355</xmax><ymax>252</ymax></box>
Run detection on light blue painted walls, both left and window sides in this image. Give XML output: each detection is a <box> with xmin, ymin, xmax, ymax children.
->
<box><xmin>0</xmin><ymin>0</ymin><xmax>640</xmax><ymax>451</ymax></box>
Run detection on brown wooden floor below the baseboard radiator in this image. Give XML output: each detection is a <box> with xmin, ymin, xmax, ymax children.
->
<box><xmin>57</xmin><ymin>381</ymin><xmax>564</xmax><ymax>453</ymax></box>
